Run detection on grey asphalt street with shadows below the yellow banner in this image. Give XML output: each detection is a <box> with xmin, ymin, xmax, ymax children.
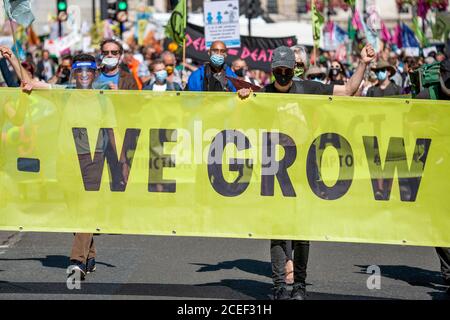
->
<box><xmin>0</xmin><ymin>232</ymin><xmax>449</xmax><ymax>300</ymax></box>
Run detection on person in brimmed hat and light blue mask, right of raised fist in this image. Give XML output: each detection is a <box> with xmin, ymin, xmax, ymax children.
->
<box><xmin>367</xmin><ymin>60</ymin><xmax>401</xmax><ymax>97</ymax></box>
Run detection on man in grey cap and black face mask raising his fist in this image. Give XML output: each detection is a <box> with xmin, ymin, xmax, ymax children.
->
<box><xmin>238</xmin><ymin>45</ymin><xmax>375</xmax><ymax>300</ymax></box>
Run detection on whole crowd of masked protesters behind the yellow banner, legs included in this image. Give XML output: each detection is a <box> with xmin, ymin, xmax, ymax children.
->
<box><xmin>0</xmin><ymin>35</ymin><xmax>450</xmax><ymax>299</ymax></box>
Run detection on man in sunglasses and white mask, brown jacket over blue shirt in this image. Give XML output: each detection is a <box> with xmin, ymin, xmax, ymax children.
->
<box><xmin>94</xmin><ymin>39</ymin><xmax>139</xmax><ymax>90</ymax></box>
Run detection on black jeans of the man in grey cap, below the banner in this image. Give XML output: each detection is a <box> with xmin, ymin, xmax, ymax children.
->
<box><xmin>270</xmin><ymin>240</ymin><xmax>309</xmax><ymax>287</ymax></box>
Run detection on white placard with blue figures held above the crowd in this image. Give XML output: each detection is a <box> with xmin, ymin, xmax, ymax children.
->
<box><xmin>203</xmin><ymin>0</ymin><xmax>241</xmax><ymax>49</ymax></box>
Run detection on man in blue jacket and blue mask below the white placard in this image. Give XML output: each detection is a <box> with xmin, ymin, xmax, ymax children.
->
<box><xmin>186</xmin><ymin>41</ymin><xmax>237</xmax><ymax>92</ymax></box>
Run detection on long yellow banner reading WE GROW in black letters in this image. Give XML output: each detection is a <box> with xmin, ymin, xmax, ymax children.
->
<box><xmin>0</xmin><ymin>89</ymin><xmax>450</xmax><ymax>246</ymax></box>
